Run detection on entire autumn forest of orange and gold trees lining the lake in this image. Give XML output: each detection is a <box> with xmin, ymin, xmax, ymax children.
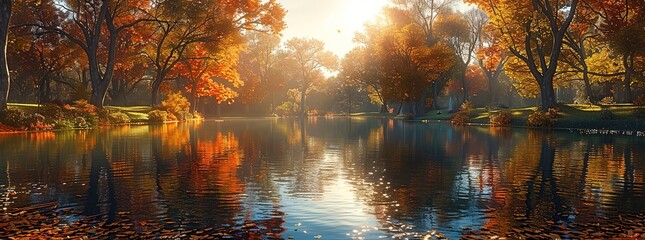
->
<box><xmin>0</xmin><ymin>0</ymin><xmax>645</xmax><ymax>129</ymax></box>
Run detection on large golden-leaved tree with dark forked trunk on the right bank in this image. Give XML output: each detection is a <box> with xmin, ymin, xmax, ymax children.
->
<box><xmin>466</xmin><ymin>0</ymin><xmax>578</xmax><ymax>110</ymax></box>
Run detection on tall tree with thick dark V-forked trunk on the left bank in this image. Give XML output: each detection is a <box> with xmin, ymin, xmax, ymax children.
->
<box><xmin>24</xmin><ymin>0</ymin><xmax>150</xmax><ymax>107</ymax></box>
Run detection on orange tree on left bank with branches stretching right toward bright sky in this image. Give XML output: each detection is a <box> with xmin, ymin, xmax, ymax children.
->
<box><xmin>145</xmin><ymin>0</ymin><xmax>285</xmax><ymax>105</ymax></box>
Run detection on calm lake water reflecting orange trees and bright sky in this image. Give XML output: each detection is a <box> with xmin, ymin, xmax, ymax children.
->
<box><xmin>0</xmin><ymin>118</ymin><xmax>645</xmax><ymax>239</ymax></box>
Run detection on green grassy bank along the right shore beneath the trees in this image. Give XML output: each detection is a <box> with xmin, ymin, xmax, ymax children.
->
<box><xmin>418</xmin><ymin>104</ymin><xmax>645</xmax><ymax>131</ymax></box>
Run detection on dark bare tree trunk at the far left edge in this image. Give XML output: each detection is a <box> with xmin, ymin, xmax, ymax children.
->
<box><xmin>0</xmin><ymin>0</ymin><xmax>12</xmax><ymax>110</ymax></box>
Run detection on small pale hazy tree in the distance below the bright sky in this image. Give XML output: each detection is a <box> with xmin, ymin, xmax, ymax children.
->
<box><xmin>285</xmin><ymin>38</ymin><xmax>338</xmax><ymax>117</ymax></box>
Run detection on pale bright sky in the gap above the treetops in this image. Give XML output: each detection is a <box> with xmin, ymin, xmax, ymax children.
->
<box><xmin>278</xmin><ymin>0</ymin><xmax>464</xmax><ymax>58</ymax></box>
